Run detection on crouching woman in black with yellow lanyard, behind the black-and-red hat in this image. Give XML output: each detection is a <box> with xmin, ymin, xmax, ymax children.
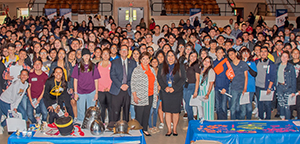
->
<box><xmin>43</xmin><ymin>67</ymin><xmax>73</xmax><ymax>123</ymax></box>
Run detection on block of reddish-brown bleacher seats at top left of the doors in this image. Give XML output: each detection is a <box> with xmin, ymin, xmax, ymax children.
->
<box><xmin>44</xmin><ymin>0</ymin><xmax>100</xmax><ymax>14</ymax></box>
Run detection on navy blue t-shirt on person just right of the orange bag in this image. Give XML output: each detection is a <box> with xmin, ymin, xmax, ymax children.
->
<box><xmin>230</xmin><ymin>61</ymin><xmax>249</xmax><ymax>91</ymax></box>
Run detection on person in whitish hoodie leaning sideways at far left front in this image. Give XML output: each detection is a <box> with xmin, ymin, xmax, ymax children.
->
<box><xmin>0</xmin><ymin>69</ymin><xmax>29</xmax><ymax>127</ymax></box>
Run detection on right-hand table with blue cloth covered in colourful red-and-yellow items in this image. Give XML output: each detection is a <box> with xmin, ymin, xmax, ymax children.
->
<box><xmin>185</xmin><ymin>120</ymin><xmax>300</xmax><ymax>144</ymax></box>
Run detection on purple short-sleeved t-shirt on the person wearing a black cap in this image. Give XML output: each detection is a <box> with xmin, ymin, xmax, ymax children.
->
<box><xmin>72</xmin><ymin>64</ymin><xmax>100</xmax><ymax>94</ymax></box>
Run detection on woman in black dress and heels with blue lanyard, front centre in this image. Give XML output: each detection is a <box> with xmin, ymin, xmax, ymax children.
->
<box><xmin>157</xmin><ymin>50</ymin><xmax>186</xmax><ymax>136</ymax></box>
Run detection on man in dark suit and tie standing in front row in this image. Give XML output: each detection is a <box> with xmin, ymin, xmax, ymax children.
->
<box><xmin>109</xmin><ymin>45</ymin><xmax>136</xmax><ymax>122</ymax></box>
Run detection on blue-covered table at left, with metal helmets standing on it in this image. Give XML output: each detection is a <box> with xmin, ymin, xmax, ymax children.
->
<box><xmin>7</xmin><ymin>129</ymin><xmax>146</xmax><ymax>144</ymax></box>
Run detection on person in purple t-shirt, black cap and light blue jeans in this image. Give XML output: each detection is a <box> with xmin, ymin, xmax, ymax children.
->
<box><xmin>72</xmin><ymin>48</ymin><xmax>100</xmax><ymax>124</ymax></box>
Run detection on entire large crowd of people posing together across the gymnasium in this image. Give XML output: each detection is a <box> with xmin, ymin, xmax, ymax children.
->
<box><xmin>0</xmin><ymin>14</ymin><xmax>300</xmax><ymax>136</ymax></box>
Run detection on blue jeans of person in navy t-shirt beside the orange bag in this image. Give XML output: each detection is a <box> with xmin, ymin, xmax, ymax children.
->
<box><xmin>229</xmin><ymin>90</ymin><xmax>246</xmax><ymax>120</ymax></box>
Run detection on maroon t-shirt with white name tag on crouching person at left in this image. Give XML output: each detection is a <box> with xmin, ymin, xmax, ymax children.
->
<box><xmin>28</xmin><ymin>71</ymin><xmax>48</xmax><ymax>99</ymax></box>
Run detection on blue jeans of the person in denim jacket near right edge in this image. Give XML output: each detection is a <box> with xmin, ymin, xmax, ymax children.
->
<box><xmin>277</xmin><ymin>85</ymin><xmax>292</xmax><ymax>119</ymax></box>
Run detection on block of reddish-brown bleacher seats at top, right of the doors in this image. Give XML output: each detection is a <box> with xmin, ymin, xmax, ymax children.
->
<box><xmin>163</xmin><ymin>0</ymin><xmax>220</xmax><ymax>14</ymax></box>
